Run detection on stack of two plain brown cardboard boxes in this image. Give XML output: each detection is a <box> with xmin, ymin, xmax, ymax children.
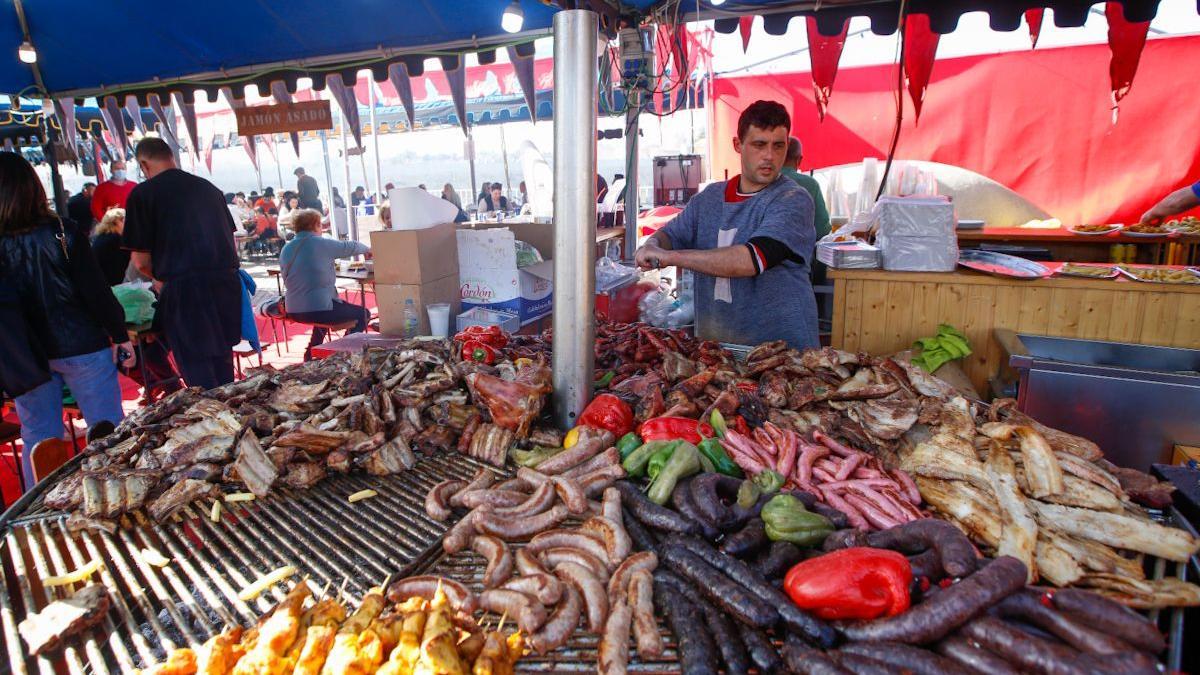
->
<box><xmin>371</xmin><ymin>223</ymin><xmax>461</xmax><ymax>335</ymax></box>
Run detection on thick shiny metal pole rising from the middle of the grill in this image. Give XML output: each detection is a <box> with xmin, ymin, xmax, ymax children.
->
<box><xmin>553</xmin><ymin>10</ymin><xmax>598</xmax><ymax>429</ymax></box>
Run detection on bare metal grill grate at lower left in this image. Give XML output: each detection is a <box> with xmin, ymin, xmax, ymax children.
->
<box><xmin>0</xmin><ymin>455</ymin><xmax>496</xmax><ymax>675</ymax></box>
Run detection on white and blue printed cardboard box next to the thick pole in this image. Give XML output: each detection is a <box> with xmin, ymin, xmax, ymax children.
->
<box><xmin>458</xmin><ymin>228</ymin><xmax>554</xmax><ymax>325</ymax></box>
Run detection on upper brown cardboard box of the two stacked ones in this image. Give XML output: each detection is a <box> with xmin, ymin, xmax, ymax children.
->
<box><xmin>371</xmin><ymin>222</ymin><xmax>458</xmax><ymax>285</ymax></box>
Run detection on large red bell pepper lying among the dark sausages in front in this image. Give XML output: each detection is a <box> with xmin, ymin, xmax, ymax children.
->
<box><xmin>784</xmin><ymin>548</ymin><xmax>912</xmax><ymax>620</ymax></box>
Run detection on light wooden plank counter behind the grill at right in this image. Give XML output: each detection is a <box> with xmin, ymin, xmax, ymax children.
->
<box><xmin>829</xmin><ymin>263</ymin><xmax>1200</xmax><ymax>393</ymax></box>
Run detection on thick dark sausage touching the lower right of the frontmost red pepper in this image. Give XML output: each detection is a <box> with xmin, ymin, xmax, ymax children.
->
<box><xmin>840</xmin><ymin>556</ymin><xmax>1026</xmax><ymax>645</ymax></box>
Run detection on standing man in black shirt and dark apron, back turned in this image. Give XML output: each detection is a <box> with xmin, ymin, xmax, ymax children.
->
<box><xmin>122</xmin><ymin>138</ymin><xmax>242</xmax><ymax>389</ymax></box>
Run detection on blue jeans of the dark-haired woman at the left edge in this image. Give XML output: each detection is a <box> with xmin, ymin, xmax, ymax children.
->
<box><xmin>16</xmin><ymin>347</ymin><xmax>125</xmax><ymax>485</ymax></box>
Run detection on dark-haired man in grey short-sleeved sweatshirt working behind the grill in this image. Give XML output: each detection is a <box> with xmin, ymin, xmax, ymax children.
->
<box><xmin>635</xmin><ymin>101</ymin><xmax>820</xmax><ymax>350</ymax></box>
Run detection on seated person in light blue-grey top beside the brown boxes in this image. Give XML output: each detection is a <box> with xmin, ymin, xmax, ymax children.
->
<box><xmin>280</xmin><ymin>209</ymin><xmax>371</xmax><ymax>360</ymax></box>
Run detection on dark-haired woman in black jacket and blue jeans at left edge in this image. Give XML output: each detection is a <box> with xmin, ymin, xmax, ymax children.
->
<box><xmin>0</xmin><ymin>153</ymin><xmax>136</xmax><ymax>485</ymax></box>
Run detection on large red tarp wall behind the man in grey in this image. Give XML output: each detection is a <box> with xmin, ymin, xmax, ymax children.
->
<box><xmin>709</xmin><ymin>36</ymin><xmax>1200</xmax><ymax>225</ymax></box>
